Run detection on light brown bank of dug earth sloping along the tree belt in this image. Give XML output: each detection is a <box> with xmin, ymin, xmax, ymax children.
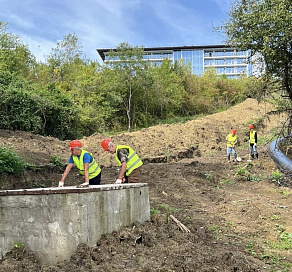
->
<box><xmin>0</xmin><ymin>99</ymin><xmax>285</xmax><ymax>167</ymax></box>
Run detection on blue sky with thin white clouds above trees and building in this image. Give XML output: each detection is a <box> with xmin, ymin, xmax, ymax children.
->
<box><xmin>0</xmin><ymin>0</ymin><xmax>234</xmax><ymax>61</ymax></box>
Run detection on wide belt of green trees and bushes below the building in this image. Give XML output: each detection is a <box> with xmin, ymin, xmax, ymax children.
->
<box><xmin>0</xmin><ymin>22</ymin><xmax>270</xmax><ymax>139</ymax></box>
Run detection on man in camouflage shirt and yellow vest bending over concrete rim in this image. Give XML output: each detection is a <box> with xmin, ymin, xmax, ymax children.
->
<box><xmin>101</xmin><ymin>138</ymin><xmax>143</xmax><ymax>184</ymax></box>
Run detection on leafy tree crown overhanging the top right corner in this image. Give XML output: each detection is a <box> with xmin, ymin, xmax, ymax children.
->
<box><xmin>218</xmin><ymin>0</ymin><xmax>292</xmax><ymax>101</ymax></box>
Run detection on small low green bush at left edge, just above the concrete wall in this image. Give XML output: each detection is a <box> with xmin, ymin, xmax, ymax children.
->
<box><xmin>0</xmin><ymin>146</ymin><xmax>31</xmax><ymax>175</ymax></box>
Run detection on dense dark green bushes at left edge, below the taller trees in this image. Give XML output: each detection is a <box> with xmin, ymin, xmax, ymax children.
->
<box><xmin>0</xmin><ymin>79</ymin><xmax>78</xmax><ymax>139</ymax></box>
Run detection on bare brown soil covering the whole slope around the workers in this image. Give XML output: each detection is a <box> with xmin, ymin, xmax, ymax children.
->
<box><xmin>0</xmin><ymin>99</ymin><xmax>292</xmax><ymax>272</ymax></box>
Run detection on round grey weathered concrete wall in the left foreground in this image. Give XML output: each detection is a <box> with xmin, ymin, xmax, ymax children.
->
<box><xmin>0</xmin><ymin>183</ymin><xmax>150</xmax><ymax>264</ymax></box>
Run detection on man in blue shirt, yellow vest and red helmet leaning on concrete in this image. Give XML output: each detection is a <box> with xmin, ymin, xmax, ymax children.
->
<box><xmin>59</xmin><ymin>140</ymin><xmax>101</xmax><ymax>187</ymax></box>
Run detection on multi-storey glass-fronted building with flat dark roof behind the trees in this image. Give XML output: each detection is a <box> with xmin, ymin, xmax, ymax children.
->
<box><xmin>97</xmin><ymin>45</ymin><xmax>253</xmax><ymax>78</ymax></box>
